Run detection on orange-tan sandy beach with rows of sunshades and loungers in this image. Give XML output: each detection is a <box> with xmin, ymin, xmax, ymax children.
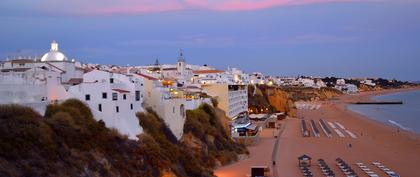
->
<box><xmin>215</xmin><ymin>89</ymin><xmax>420</xmax><ymax>177</ymax></box>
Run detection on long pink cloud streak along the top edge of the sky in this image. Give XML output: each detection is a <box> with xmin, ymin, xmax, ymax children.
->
<box><xmin>40</xmin><ymin>0</ymin><xmax>370</xmax><ymax>15</ymax></box>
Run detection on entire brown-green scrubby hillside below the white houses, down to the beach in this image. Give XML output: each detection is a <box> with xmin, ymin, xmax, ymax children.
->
<box><xmin>0</xmin><ymin>99</ymin><xmax>247</xmax><ymax>177</ymax></box>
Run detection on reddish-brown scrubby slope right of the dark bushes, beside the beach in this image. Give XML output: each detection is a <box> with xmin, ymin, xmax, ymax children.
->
<box><xmin>137</xmin><ymin>105</ymin><xmax>248</xmax><ymax>176</ymax></box>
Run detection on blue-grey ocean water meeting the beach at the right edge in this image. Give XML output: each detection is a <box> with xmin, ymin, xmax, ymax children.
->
<box><xmin>347</xmin><ymin>91</ymin><xmax>420</xmax><ymax>134</ymax></box>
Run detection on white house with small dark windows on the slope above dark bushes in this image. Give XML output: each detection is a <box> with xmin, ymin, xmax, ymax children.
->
<box><xmin>69</xmin><ymin>70</ymin><xmax>144</xmax><ymax>139</ymax></box>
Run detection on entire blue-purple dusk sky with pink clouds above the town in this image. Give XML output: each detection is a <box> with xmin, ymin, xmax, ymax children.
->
<box><xmin>0</xmin><ymin>0</ymin><xmax>420</xmax><ymax>81</ymax></box>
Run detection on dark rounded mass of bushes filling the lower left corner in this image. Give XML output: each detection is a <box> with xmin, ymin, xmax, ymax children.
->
<box><xmin>0</xmin><ymin>100</ymin><xmax>153</xmax><ymax>177</ymax></box>
